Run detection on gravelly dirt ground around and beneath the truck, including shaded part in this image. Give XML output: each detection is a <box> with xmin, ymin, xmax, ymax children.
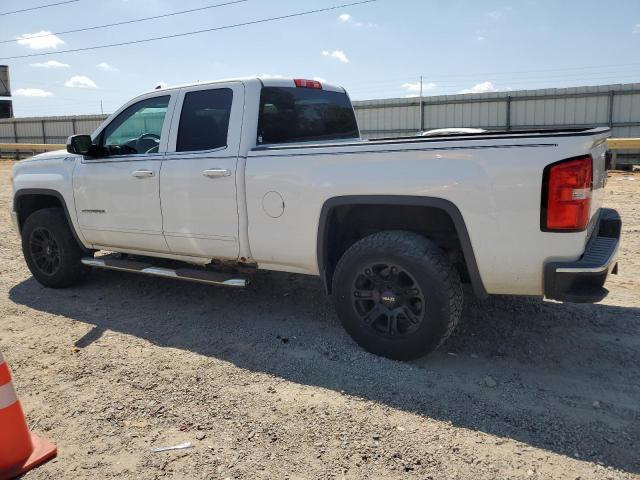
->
<box><xmin>0</xmin><ymin>162</ymin><xmax>640</xmax><ymax>480</ymax></box>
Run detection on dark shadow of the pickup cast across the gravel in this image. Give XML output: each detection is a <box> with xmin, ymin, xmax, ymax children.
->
<box><xmin>10</xmin><ymin>272</ymin><xmax>640</xmax><ymax>473</ymax></box>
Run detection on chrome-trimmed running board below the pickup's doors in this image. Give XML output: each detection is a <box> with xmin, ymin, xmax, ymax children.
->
<box><xmin>82</xmin><ymin>257</ymin><xmax>249</xmax><ymax>288</ymax></box>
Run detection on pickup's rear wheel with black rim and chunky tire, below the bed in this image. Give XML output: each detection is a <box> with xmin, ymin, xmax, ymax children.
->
<box><xmin>333</xmin><ymin>231</ymin><xmax>462</xmax><ymax>360</ymax></box>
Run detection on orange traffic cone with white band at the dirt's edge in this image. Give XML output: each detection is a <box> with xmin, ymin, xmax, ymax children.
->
<box><xmin>0</xmin><ymin>353</ymin><xmax>57</xmax><ymax>480</ymax></box>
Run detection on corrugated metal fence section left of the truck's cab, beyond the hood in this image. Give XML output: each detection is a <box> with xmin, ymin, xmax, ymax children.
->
<box><xmin>0</xmin><ymin>115</ymin><xmax>107</xmax><ymax>143</ymax></box>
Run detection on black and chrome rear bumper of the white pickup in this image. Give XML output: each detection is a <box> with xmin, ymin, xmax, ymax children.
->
<box><xmin>544</xmin><ymin>208</ymin><xmax>622</xmax><ymax>303</ymax></box>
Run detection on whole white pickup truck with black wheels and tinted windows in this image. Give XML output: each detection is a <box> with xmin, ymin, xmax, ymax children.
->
<box><xmin>12</xmin><ymin>78</ymin><xmax>621</xmax><ymax>359</ymax></box>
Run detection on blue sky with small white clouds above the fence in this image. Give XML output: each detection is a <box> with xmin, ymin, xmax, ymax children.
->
<box><xmin>0</xmin><ymin>0</ymin><xmax>640</xmax><ymax>117</ymax></box>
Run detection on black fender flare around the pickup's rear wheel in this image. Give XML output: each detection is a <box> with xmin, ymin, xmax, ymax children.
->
<box><xmin>317</xmin><ymin>195</ymin><xmax>487</xmax><ymax>298</ymax></box>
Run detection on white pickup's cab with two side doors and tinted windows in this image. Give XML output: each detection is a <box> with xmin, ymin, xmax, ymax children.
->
<box><xmin>62</xmin><ymin>79</ymin><xmax>359</xmax><ymax>260</ymax></box>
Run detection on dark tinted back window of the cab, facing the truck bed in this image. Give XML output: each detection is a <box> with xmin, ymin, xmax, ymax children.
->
<box><xmin>257</xmin><ymin>86</ymin><xmax>360</xmax><ymax>145</ymax></box>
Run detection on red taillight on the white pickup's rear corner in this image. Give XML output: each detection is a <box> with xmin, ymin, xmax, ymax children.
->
<box><xmin>541</xmin><ymin>155</ymin><xmax>593</xmax><ymax>232</ymax></box>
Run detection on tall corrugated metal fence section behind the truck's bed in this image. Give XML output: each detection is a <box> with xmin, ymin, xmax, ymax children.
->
<box><xmin>354</xmin><ymin>83</ymin><xmax>640</xmax><ymax>138</ymax></box>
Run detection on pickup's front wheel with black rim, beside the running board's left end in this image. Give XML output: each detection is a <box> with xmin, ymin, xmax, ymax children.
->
<box><xmin>21</xmin><ymin>208</ymin><xmax>88</xmax><ymax>288</ymax></box>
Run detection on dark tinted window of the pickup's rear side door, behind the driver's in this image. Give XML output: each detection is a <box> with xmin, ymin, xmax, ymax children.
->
<box><xmin>176</xmin><ymin>88</ymin><xmax>233</xmax><ymax>152</ymax></box>
